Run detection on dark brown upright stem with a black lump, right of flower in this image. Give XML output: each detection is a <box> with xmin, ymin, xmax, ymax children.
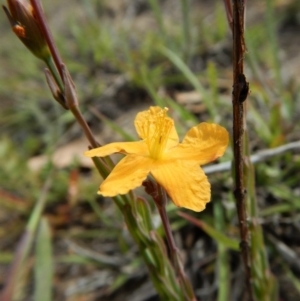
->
<box><xmin>232</xmin><ymin>0</ymin><xmax>254</xmax><ymax>301</ymax></box>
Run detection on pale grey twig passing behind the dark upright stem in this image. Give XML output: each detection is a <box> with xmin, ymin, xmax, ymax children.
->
<box><xmin>203</xmin><ymin>141</ymin><xmax>300</xmax><ymax>174</ymax></box>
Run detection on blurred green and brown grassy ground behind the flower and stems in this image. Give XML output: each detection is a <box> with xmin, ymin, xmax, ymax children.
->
<box><xmin>0</xmin><ymin>0</ymin><xmax>300</xmax><ymax>301</ymax></box>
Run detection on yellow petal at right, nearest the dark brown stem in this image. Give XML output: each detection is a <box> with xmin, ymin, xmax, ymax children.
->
<box><xmin>167</xmin><ymin>122</ymin><xmax>229</xmax><ymax>165</ymax></box>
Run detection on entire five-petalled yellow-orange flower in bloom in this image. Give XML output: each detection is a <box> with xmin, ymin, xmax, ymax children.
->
<box><xmin>85</xmin><ymin>107</ymin><xmax>228</xmax><ymax>211</ymax></box>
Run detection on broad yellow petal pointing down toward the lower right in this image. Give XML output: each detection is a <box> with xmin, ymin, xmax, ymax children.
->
<box><xmin>151</xmin><ymin>161</ymin><xmax>210</xmax><ymax>211</ymax></box>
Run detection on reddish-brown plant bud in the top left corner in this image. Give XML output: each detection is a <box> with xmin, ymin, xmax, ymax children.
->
<box><xmin>3</xmin><ymin>0</ymin><xmax>50</xmax><ymax>60</ymax></box>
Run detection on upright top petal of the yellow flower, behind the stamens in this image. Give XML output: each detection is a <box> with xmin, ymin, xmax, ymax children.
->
<box><xmin>134</xmin><ymin>107</ymin><xmax>179</xmax><ymax>149</ymax></box>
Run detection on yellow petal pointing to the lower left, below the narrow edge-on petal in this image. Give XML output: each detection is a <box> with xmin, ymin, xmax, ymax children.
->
<box><xmin>98</xmin><ymin>155</ymin><xmax>153</xmax><ymax>196</ymax></box>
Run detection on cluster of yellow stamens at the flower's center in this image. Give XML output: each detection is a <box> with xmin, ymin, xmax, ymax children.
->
<box><xmin>145</xmin><ymin>108</ymin><xmax>173</xmax><ymax>160</ymax></box>
